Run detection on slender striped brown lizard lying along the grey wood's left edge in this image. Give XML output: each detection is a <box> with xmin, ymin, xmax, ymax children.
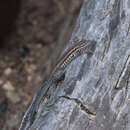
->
<box><xmin>19</xmin><ymin>40</ymin><xmax>96</xmax><ymax>130</ymax></box>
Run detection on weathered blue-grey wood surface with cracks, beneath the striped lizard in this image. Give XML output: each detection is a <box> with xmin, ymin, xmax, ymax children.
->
<box><xmin>23</xmin><ymin>0</ymin><xmax>130</xmax><ymax>130</ymax></box>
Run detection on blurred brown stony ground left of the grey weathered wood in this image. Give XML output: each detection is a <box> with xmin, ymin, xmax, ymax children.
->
<box><xmin>0</xmin><ymin>0</ymin><xmax>83</xmax><ymax>130</ymax></box>
